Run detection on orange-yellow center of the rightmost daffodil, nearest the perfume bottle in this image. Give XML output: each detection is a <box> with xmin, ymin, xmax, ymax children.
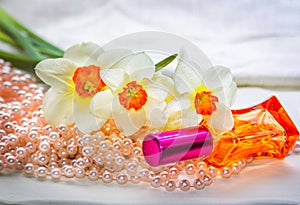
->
<box><xmin>193</xmin><ymin>85</ymin><xmax>219</xmax><ymax>115</ymax></box>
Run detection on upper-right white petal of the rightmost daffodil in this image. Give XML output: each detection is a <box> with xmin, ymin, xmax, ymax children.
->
<box><xmin>203</xmin><ymin>66</ymin><xmax>233</xmax><ymax>90</ymax></box>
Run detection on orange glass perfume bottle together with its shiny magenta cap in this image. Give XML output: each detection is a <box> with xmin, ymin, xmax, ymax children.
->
<box><xmin>143</xmin><ymin>96</ymin><xmax>299</xmax><ymax>167</ymax></box>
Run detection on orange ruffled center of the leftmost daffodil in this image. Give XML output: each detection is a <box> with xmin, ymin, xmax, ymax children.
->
<box><xmin>72</xmin><ymin>65</ymin><xmax>107</xmax><ymax>97</ymax></box>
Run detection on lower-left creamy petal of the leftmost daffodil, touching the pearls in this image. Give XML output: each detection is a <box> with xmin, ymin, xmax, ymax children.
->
<box><xmin>43</xmin><ymin>88</ymin><xmax>73</xmax><ymax>125</ymax></box>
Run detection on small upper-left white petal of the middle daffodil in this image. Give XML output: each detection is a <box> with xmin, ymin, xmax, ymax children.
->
<box><xmin>100</xmin><ymin>68</ymin><xmax>127</xmax><ymax>91</ymax></box>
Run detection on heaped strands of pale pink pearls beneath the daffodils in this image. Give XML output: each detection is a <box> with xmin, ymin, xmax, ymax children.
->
<box><xmin>0</xmin><ymin>60</ymin><xmax>300</xmax><ymax>191</ymax></box>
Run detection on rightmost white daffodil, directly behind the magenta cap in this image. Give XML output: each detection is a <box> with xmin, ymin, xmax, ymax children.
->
<box><xmin>166</xmin><ymin>61</ymin><xmax>237</xmax><ymax>131</ymax></box>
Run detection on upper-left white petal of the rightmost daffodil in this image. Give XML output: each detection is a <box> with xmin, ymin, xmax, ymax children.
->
<box><xmin>174</xmin><ymin>61</ymin><xmax>202</xmax><ymax>94</ymax></box>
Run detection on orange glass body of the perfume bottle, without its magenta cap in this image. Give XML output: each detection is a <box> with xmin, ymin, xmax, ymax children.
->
<box><xmin>205</xmin><ymin>96</ymin><xmax>299</xmax><ymax>167</ymax></box>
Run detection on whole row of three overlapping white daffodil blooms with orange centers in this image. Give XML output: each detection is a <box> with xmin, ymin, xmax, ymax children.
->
<box><xmin>35</xmin><ymin>43</ymin><xmax>236</xmax><ymax>136</ymax></box>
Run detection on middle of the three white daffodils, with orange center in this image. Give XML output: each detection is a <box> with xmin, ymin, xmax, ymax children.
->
<box><xmin>92</xmin><ymin>53</ymin><xmax>168</xmax><ymax>135</ymax></box>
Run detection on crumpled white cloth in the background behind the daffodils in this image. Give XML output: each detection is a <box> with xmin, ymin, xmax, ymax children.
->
<box><xmin>0</xmin><ymin>0</ymin><xmax>300</xmax><ymax>88</ymax></box>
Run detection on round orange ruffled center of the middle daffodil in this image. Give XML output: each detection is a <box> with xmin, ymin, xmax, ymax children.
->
<box><xmin>118</xmin><ymin>81</ymin><xmax>148</xmax><ymax>110</ymax></box>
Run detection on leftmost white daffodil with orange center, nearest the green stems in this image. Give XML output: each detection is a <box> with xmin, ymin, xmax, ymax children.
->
<box><xmin>35</xmin><ymin>43</ymin><xmax>127</xmax><ymax>133</ymax></box>
